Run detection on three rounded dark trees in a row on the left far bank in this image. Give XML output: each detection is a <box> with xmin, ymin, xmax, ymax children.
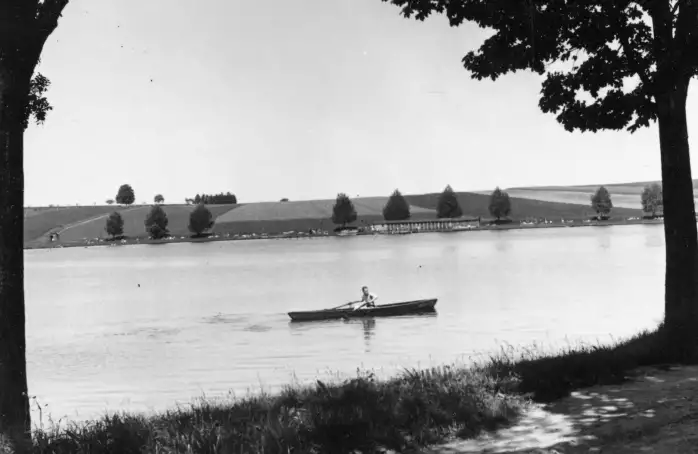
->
<box><xmin>104</xmin><ymin>204</ymin><xmax>214</xmax><ymax>239</ymax></box>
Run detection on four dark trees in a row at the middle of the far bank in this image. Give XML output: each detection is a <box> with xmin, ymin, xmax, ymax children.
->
<box><xmin>332</xmin><ymin>185</ymin><xmax>511</xmax><ymax>226</ymax></box>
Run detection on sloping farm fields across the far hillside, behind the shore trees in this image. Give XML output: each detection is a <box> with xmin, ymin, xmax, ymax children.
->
<box><xmin>24</xmin><ymin>183</ymin><xmax>641</xmax><ymax>247</ymax></box>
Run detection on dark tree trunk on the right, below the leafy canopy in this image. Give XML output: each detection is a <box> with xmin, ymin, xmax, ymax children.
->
<box><xmin>657</xmin><ymin>81</ymin><xmax>698</xmax><ymax>359</ymax></box>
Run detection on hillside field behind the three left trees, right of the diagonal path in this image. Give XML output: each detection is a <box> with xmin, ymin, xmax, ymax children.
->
<box><xmin>50</xmin><ymin>205</ymin><xmax>238</xmax><ymax>242</ymax></box>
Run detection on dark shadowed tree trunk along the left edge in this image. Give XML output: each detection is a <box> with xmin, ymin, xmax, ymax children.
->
<box><xmin>0</xmin><ymin>63</ymin><xmax>32</xmax><ymax>452</ymax></box>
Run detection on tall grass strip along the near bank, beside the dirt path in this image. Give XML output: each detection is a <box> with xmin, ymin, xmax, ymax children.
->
<box><xmin>23</xmin><ymin>326</ymin><xmax>695</xmax><ymax>454</ymax></box>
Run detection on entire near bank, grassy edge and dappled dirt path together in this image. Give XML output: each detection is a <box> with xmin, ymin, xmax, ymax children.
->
<box><xmin>20</xmin><ymin>325</ymin><xmax>698</xmax><ymax>454</ymax></box>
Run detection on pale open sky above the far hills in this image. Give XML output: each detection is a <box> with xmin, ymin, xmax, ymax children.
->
<box><xmin>25</xmin><ymin>0</ymin><xmax>698</xmax><ymax>206</ymax></box>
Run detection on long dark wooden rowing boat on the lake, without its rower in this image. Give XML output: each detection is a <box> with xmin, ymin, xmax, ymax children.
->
<box><xmin>288</xmin><ymin>298</ymin><xmax>437</xmax><ymax>322</ymax></box>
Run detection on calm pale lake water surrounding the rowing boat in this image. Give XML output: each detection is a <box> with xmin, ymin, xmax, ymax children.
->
<box><xmin>26</xmin><ymin>225</ymin><xmax>664</xmax><ymax>421</ymax></box>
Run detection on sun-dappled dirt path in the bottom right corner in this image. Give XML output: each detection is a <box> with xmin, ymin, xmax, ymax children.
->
<box><xmin>424</xmin><ymin>366</ymin><xmax>698</xmax><ymax>454</ymax></box>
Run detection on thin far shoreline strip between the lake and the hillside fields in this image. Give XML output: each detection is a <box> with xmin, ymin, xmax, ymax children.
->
<box><xmin>24</xmin><ymin>219</ymin><xmax>664</xmax><ymax>250</ymax></box>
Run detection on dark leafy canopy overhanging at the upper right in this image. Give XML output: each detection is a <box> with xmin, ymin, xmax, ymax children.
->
<box><xmin>382</xmin><ymin>0</ymin><xmax>698</xmax><ymax>132</ymax></box>
